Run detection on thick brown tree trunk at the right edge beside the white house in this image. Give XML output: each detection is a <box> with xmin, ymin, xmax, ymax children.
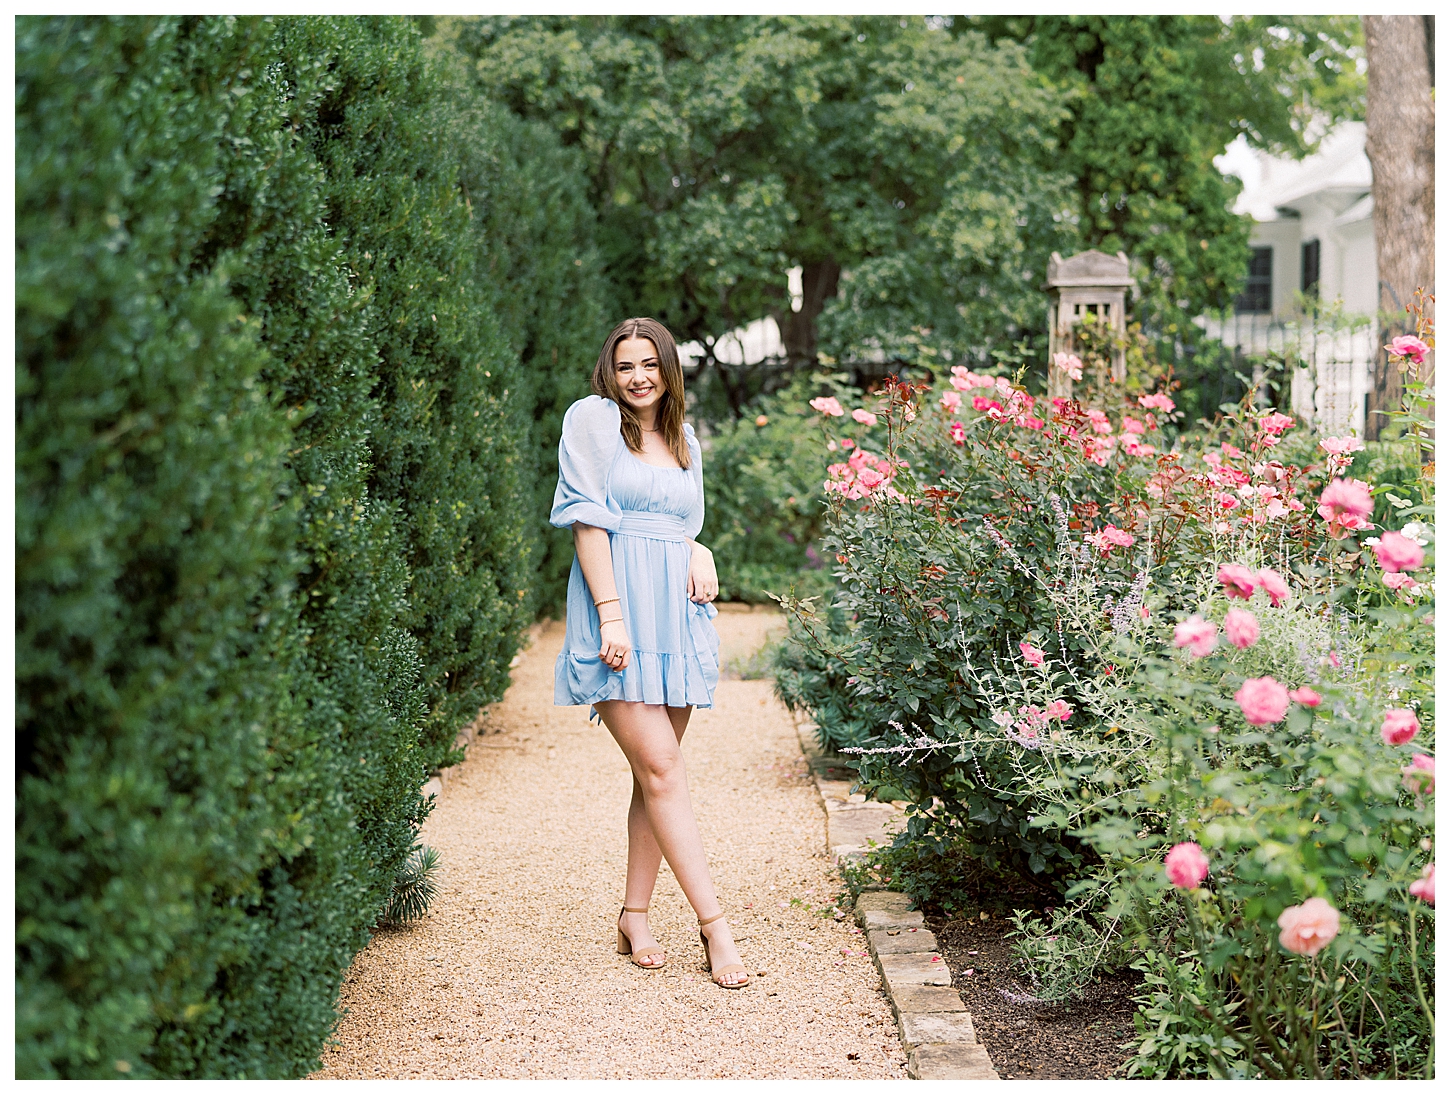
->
<box><xmin>1363</xmin><ymin>15</ymin><xmax>1436</xmax><ymax>439</ymax></box>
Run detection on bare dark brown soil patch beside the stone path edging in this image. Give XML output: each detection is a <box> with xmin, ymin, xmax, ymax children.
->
<box><xmin>927</xmin><ymin>912</ymin><xmax>1138</xmax><ymax>1079</ymax></box>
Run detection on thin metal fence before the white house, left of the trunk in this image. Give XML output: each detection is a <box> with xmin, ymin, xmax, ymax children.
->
<box><xmin>1199</xmin><ymin>313</ymin><xmax>1379</xmax><ymax>437</ymax></box>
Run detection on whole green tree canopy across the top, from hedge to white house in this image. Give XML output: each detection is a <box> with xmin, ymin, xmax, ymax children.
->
<box><xmin>438</xmin><ymin>16</ymin><xmax>1362</xmax><ymax>410</ymax></box>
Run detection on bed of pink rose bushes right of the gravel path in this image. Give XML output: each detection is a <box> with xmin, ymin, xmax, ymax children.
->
<box><xmin>777</xmin><ymin>323</ymin><xmax>1434</xmax><ymax>1078</ymax></box>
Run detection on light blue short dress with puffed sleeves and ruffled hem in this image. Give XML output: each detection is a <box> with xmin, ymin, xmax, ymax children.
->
<box><xmin>550</xmin><ymin>396</ymin><xmax>719</xmax><ymax>715</ymax></box>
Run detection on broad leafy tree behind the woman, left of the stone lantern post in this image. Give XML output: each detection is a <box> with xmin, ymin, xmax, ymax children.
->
<box><xmin>439</xmin><ymin>16</ymin><xmax>1069</xmax><ymax>412</ymax></box>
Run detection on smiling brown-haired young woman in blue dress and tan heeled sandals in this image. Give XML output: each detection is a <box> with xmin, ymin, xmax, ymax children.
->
<box><xmin>550</xmin><ymin>319</ymin><xmax>750</xmax><ymax>989</ymax></box>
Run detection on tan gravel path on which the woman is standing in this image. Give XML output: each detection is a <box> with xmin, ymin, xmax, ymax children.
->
<box><xmin>315</xmin><ymin>606</ymin><xmax>906</xmax><ymax>1079</ymax></box>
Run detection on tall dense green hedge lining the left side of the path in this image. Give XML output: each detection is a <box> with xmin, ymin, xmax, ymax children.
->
<box><xmin>16</xmin><ymin>17</ymin><xmax>573</xmax><ymax>1078</ymax></box>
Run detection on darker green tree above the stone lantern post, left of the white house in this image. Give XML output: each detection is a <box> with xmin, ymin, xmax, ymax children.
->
<box><xmin>953</xmin><ymin>16</ymin><xmax>1360</xmax><ymax>335</ymax></box>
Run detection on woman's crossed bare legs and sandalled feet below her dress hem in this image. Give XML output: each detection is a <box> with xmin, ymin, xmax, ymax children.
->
<box><xmin>595</xmin><ymin>699</ymin><xmax>742</xmax><ymax>980</ymax></box>
